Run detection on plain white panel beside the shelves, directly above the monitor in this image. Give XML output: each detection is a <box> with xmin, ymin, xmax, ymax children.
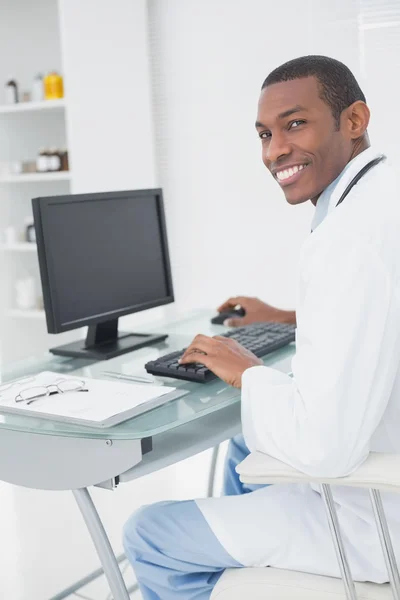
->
<box><xmin>59</xmin><ymin>0</ymin><xmax>155</xmax><ymax>193</ymax></box>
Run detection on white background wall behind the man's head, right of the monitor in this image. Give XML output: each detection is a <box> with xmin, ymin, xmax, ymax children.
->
<box><xmin>149</xmin><ymin>0</ymin><xmax>359</xmax><ymax>316</ymax></box>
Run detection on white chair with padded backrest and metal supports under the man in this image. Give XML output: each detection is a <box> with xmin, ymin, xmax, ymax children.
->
<box><xmin>211</xmin><ymin>452</ymin><xmax>400</xmax><ymax>600</ymax></box>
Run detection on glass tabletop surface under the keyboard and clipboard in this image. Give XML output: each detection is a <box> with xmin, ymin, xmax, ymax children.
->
<box><xmin>0</xmin><ymin>311</ymin><xmax>294</xmax><ymax>440</ymax></box>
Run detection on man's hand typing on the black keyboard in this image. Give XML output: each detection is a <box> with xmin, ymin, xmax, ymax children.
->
<box><xmin>180</xmin><ymin>335</ymin><xmax>264</xmax><ymax>388</ymax></box>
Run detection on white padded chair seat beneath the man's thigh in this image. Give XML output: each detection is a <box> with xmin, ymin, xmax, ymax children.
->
<box><xmin>211</xmin><ymin>568</ymin><xmax>393</xmax><ymax>600</ymax></box>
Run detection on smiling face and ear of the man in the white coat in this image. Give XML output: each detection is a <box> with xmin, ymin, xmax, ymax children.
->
<box><xmin>256</xmin><ymin>74</ymin><xmax>369</xmax><ymax>204</ymax></box>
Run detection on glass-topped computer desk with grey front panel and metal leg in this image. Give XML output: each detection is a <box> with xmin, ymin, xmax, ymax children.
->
<box><xmin>0</xmin><ymin>311</ymin><xmax>294</xmax><ymax>600</ymax></box>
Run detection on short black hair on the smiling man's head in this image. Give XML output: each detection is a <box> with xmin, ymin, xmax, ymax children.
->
<box><xmin>261</xmin><ymin>55</ymin><xmax>366</xmax><ymax>129</ymax></box>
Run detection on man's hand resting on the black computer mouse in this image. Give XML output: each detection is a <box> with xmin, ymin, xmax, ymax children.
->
<box><xmin>217</xmin><ymin>296</ymin><xmax>296</xmax><ymax>327</ymax></box>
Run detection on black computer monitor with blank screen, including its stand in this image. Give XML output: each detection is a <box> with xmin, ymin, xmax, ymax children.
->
<box><xmin>32</xmin><ymin>189</ymin><xmax>174</xmax><ymax>359</ymax></box>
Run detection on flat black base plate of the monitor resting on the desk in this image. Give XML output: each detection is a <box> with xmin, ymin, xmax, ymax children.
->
<box><xmin>50</xmin><ymin>332</ymin><xmax>168</xmax><ymax>360</ymax></box>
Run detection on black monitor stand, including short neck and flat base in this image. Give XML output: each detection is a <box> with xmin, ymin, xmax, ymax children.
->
<box><xmin>50</xmin><ymin>319</ymin><xmax>168</xmax><ymax>360</ymax></box>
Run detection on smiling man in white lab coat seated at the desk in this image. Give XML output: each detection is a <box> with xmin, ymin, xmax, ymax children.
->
<box><xmin>125</xmin><ymin>56</ymin><xmax>400</xmax><ymax>600</ymax></box>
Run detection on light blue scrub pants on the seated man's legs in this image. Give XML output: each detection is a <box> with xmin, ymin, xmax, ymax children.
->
<box><xmin>124</xmin><ymin>435</ymin><xmax>262</xmax><ymax>600</ymax></box>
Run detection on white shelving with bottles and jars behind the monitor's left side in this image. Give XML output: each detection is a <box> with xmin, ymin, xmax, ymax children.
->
<box><xmin>0</xmin><ymin>0</ymin><xmax>70</xmax><ymax>366</ymax></box>
